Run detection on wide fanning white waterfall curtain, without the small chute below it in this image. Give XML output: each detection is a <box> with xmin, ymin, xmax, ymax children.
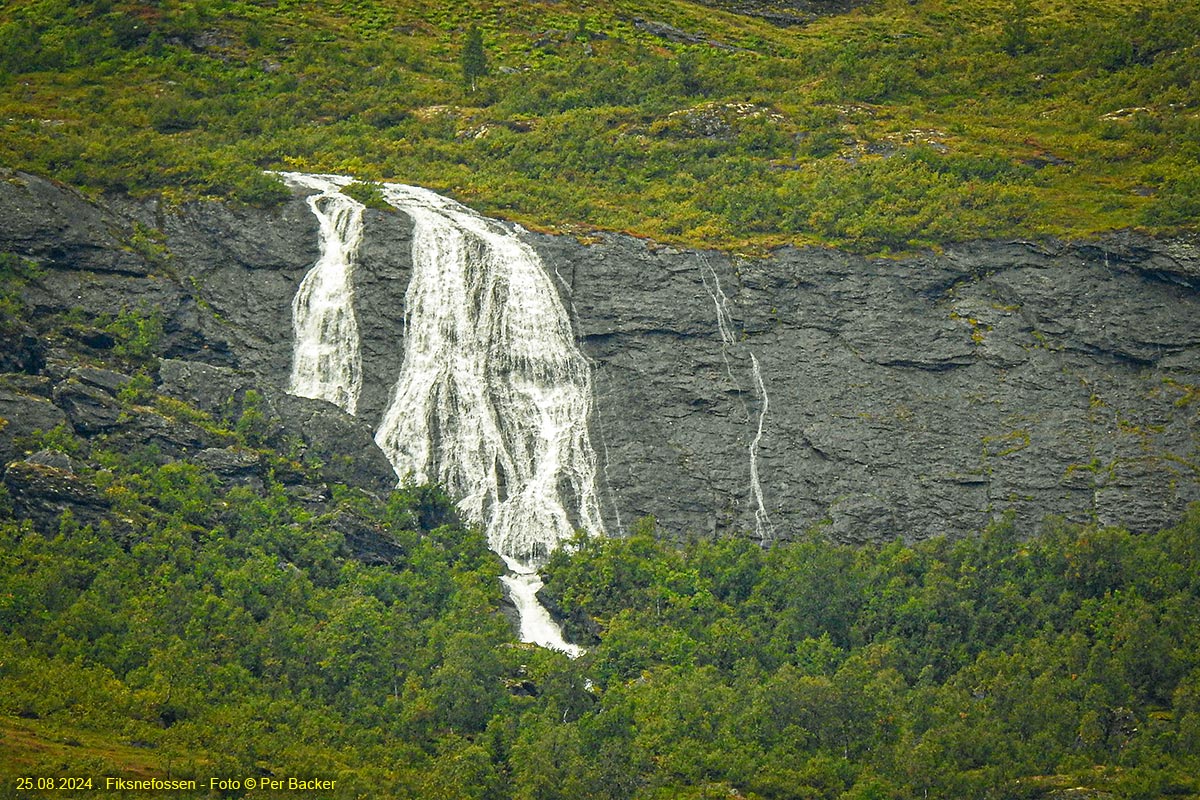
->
<box><xmin>376</xmin><ymin>184</ymin><xmax>604</xmax><ymax>572</ymax></box>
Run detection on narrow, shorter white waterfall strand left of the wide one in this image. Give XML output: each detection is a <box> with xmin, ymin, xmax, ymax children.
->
<box><xmin>283</xmin><ymin>173</ymin><xmax>362</xmax><ymax>414</ymax></box>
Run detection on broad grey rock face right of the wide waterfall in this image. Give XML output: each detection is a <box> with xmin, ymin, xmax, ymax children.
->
<box><xmin>541</xmin><ymin>236</ymin><xmax>1200</xmax><ymax>541</ymax></box>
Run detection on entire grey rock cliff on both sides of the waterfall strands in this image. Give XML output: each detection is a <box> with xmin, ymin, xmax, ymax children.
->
<box><xmin>0</xmin><ymin>172</ymin><xmax>1200</xmax><ymax>542</ymax></box>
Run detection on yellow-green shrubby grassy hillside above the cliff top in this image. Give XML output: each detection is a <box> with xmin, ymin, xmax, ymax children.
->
<box><xmin>0</xmin><ymin>0</ymin><xmax>1200</xmax><ymax>251</ymax></box>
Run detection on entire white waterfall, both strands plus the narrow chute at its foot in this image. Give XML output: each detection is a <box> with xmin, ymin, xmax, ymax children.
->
<box><xmin>283</xmin><ymin>173</ymin><xmax>604</xmax><ymax>656</ymax></box>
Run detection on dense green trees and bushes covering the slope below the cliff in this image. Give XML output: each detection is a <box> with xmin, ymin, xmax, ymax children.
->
<box><xmin>0</xmin><ymin>443</ymin><xmax>1200</xmax><ymax>800</ymax></box>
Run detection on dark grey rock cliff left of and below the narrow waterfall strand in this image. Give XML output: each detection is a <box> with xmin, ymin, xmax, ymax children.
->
<box><xmin>0</xmin><ymin>174</ymin><xmax>395</xmax><ymax>510</ymax></box>
